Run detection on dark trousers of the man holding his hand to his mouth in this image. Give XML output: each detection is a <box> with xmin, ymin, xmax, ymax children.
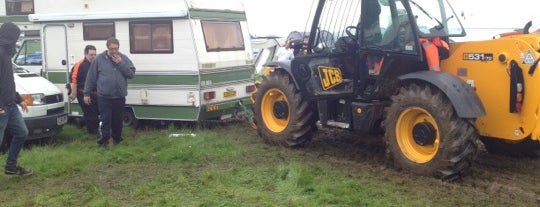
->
<box><xmin>97</xmin><ymin>96</ymin><xmax>126</xmax><ymax>145</ymax></box>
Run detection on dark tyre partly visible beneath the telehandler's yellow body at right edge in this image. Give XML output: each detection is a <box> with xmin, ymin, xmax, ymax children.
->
<box><xmin>480</xmin><ymin>137</ymin><xmax>540</xmax><ymax>158</ymax></box>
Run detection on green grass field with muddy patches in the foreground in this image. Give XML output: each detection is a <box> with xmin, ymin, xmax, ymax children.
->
<box><xmin>0</xmin><ymin>123</ymin><xmax>540</xmax><ymax>207</ymax></box>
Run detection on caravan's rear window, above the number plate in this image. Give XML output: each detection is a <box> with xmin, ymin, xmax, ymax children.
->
<box><xmin>201</xmin><ymin>21</ymin><xmax>244</xmax><ymax>52</ymax></box>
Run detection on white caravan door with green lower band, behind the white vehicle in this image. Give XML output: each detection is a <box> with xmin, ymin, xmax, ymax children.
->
<box><xmin>41</xmin><ymin>24</ymin><xmax>71</xmax><ymax>114</ymax></box>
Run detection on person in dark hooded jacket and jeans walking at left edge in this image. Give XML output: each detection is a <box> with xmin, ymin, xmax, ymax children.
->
<box><xmin>0</xmin><ymin>23</ymin><xmax>32</xmax><ymax>175</ymax></box>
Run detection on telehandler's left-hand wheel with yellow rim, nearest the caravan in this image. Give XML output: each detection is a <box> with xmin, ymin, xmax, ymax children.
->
<box><xmin>253</xmin><ymin>71</ymin><xmax>317</xmax><ymax>147</ymax></box>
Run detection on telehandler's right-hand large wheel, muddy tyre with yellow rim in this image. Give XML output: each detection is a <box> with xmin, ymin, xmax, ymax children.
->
<box><xmin>384</xmin><ymin>84</ymin><xmax>479</xmax><ymax>181</ymax></box>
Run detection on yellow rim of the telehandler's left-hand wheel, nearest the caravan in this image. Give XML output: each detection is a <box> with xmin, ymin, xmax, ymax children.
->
<box><xmin>261</xmin><ymin>88</ymin><xmax>289</xmax><ymax>132</ymax></box>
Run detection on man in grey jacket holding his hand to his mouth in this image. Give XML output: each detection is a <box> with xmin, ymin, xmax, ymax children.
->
<box><xmin>84</xmin><ymin>37</ymin><xmax>135</xmax><ymax>149</ymax></box>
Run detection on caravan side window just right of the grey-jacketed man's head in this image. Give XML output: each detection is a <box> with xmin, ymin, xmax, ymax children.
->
<box><xmin>129</xmin><ymin>21</ymin><xmax>173</xmax><ymax>53</ymax></box>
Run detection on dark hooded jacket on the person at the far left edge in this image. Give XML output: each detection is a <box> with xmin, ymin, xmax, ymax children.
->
<box><xmin>0</xmin><ymin>23</ymin><xmax>22</xmax><ymax>108</ymax></box>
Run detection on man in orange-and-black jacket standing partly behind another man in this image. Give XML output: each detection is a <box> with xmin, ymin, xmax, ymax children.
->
<box><xmin>69</xmin><ymin>45</ymin><xmax>99</xmax><ymax>134</ymax></box>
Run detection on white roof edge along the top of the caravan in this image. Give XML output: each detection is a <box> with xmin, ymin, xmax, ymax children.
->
<box><xmin>28</xmin><ymin>0</ymin><xmax>244</xmax><ymax>22</ymax></box>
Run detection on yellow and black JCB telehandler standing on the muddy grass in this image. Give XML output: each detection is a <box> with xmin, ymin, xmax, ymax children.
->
<box><xmin>252</xmin><ymin>0</ymin><xmax>540</xmax><ymax>180</ymax></box>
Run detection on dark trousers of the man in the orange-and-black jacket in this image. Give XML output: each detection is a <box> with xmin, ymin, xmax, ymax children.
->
<box><xmin>77</xmin><ymin>91</ymin><xmax>99</xmax><ymax>134</ymax></box>
